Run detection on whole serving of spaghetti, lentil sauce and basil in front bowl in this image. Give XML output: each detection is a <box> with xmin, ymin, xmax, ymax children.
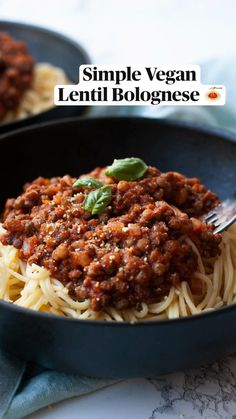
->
<box><xmin>0</xmin><ymin>157</ymin><xmax>236</xmax><ymax>322</ymax></box>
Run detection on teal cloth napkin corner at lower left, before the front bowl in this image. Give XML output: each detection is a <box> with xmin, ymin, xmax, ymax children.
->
<box><xmin>0</xmin><ymin>353</ymin><xmax>118</xmax><ymax>419</ymax></box>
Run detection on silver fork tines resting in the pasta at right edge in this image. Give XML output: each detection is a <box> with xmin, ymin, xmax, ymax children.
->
<box><xmin>204</xmin><ymin>199</ymin><xmax>236</xmax><ymax>234</ymax></box>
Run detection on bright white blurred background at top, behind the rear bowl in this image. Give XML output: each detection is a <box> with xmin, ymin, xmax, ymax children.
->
<box><xmin>0</xmin><ymin>0</ymin><xmax>236</xmax><ymax>64</ymax></box>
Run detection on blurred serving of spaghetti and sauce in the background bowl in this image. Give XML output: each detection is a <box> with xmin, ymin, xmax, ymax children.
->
<box><xmin>0</xmin><ymin>32</ymin><xmax>68</xmax><ymax>123</ymax></box>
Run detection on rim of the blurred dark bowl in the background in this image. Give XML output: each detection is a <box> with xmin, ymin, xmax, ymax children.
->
<box><xmin>0</xmin><ymin>19</ymin><xmax>92</xmax><ymax>132</ymax></box>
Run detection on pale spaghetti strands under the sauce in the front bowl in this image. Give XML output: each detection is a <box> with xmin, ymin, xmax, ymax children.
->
<box><xmin>0</xmin><ymin>224</ymin><xmax>236</xmax><ymax>323</ymax></box>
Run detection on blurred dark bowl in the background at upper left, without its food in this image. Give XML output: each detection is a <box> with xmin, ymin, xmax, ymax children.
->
<box><xmin>0</xmin><ymin>21</ymin><xmax>90</xmax><ymax>134</ymax></box>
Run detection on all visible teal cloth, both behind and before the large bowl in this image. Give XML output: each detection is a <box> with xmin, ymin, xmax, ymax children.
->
<box><xmin>0</xmin><ymin>59</ymin><xmax>236</xmax><ymax>419</ymax></box>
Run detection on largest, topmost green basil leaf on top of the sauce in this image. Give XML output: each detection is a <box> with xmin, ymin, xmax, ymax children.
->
<box><xmin>105</xmin><ymin>157</ymin><xmax>148</xmax><ymax>181</ymax></box>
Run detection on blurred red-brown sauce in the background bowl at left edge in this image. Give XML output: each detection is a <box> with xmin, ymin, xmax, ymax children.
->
<box><xmin>0</xmin><ymin>33</ymin><xmax>34</xmax><ymax>121</ymax></box>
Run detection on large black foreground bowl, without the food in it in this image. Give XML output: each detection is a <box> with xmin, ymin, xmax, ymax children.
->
<box><xmin>0</xmin><ymin>118</ymin><xmax>236</xmax><ymax>377</ymax></box>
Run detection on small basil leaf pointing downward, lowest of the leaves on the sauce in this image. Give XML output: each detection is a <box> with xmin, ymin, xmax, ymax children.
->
<box><xmin>83</xmin><ymin>186</ymin><xmax>112</xmax><ymax>215</ymax></box>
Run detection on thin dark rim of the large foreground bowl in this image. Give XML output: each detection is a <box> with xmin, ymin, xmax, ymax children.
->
<box><xmin>0</xmin><ymin>116</ymin><xmax>236</xmax><ymax>328</ymax></box>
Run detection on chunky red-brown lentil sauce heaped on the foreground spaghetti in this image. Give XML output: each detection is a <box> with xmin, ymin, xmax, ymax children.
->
<box><xmin>0</xmin><ymin>167</ymin><xmax>221</xmax><ymax>311</ymax></box>
